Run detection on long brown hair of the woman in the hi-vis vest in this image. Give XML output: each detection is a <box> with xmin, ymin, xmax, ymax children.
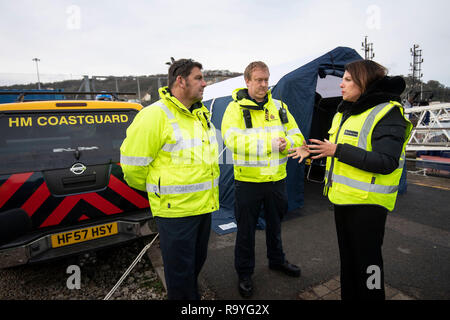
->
<box><xmin>345</xmin><ymin>60</ymin><xmax>388</xmax><ymax>93</ymax></box>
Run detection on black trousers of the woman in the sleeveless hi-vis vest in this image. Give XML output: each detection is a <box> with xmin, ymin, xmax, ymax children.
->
<box><xmin>334</xmin><ymin>205</ymin><xmax>387</xmax><ymax>300</ymax></box>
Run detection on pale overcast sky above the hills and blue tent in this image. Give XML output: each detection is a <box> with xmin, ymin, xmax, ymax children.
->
<box><xmin>0</xmin><ymin>0</ymin><xmax>450</xmax><ymax>86</ymax></box>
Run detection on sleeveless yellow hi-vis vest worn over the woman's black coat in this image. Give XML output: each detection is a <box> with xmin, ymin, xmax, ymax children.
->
<box><xmin>324</xmin><ymin>101</ymin><xmax>412</xmax><ymax>211</ymax></box>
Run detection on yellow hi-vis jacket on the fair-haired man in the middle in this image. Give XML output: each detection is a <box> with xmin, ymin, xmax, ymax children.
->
<box><xmin>222</xmin><ymin>89</ymin><xmax>304</xmax><ymax>182</ymax></box>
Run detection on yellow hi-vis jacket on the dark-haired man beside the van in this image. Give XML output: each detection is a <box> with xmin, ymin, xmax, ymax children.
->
<box><xmin>120</xmin><ymin>87</ymin><xmax>219</xmax><ymax>218</ymax></box>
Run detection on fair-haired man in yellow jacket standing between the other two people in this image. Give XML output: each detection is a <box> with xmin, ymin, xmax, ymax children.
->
<box><xmin>222</xmin><ymin>61</ymin><xmax>307</xmax><ymax>297</ymax></box>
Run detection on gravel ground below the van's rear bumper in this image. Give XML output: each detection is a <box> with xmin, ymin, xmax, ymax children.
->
<box><xmin>0</xmin><ymin>237</ymin><xmax>215</xmax><ymax>300</ymax></box>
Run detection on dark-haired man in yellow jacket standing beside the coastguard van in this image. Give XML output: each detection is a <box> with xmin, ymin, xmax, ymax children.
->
<box><xmin>120</xmin><ymin>59</ymin><xmax>219</xmax><ymax>300</ymax></box>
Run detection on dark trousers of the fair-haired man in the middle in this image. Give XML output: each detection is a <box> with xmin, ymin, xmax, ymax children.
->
<box><xmin>234</xmin><ymin>179</ymin><xmax>287</xmax><ymax>278</ymax></box>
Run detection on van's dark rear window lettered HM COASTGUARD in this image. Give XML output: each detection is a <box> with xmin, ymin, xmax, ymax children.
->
<box><xmin>0</xmin><ymin>110</ymin><xmax>137</xmax><ymax>174</ymax></box>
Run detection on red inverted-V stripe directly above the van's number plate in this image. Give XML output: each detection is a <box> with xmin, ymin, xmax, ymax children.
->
<box><xmin>41</xmin><ymin>193</ymin><xmax>123</xmax><ymax>227</ymax></box>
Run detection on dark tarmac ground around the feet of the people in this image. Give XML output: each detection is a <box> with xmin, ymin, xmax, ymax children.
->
<box><xmin>200</xmin><ymin>174</ymin><xmax>450</xmax><ymax>300</ymax></box>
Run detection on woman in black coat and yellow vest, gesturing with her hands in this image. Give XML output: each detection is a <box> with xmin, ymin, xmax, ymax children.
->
<box><xmin>290</xmin><ymin>60</ymin><xmax>412</xmax><ymax>300</ymax></box>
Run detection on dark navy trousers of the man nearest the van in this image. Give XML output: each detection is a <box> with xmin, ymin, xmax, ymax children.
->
<box><xmin>155</xmin><ymin>213</ymin><xmax>211</xmax><ymax>300</ymax></box>
